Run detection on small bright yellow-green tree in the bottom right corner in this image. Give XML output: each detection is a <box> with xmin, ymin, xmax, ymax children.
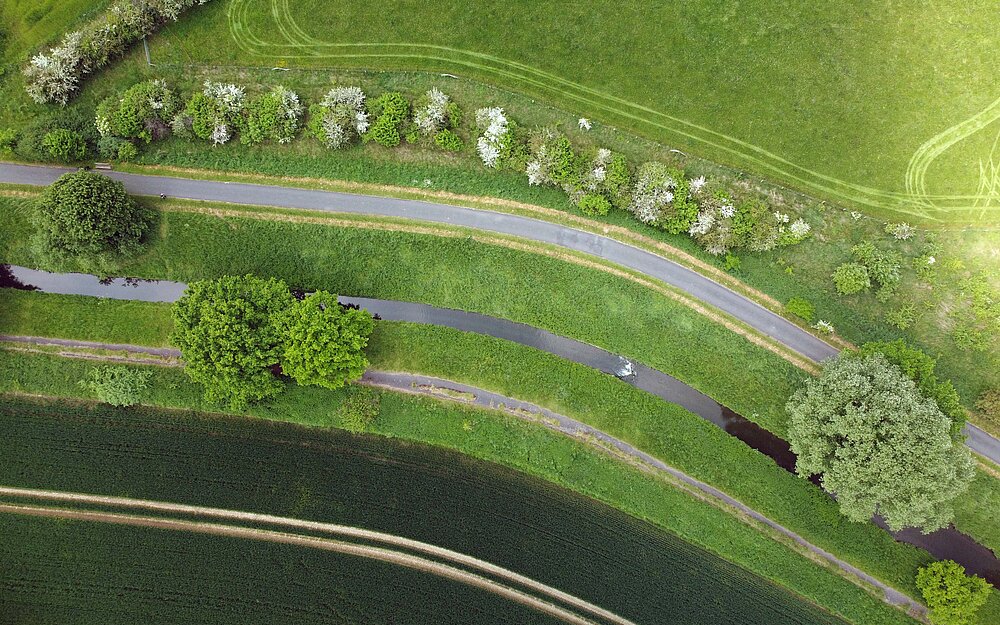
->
<box><xmin>917</xmin><ymin>560</ymin><xmax>990</xmax><ymax>625</ymax></box>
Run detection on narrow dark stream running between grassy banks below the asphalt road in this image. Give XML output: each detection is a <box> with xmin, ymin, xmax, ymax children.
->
<box><xmin>0</xmin><ymin>265</ymin><xmax>1000</xmax><ymax>588</ymax></box>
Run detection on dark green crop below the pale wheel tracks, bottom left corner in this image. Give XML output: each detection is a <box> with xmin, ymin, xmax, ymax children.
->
<box><xmin>0</xmin><ymin>514</ymin><xmax>560</xmax><ymax>625</ymax></box>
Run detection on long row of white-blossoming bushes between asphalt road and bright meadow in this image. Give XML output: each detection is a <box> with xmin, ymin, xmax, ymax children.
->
<box><xmin>23</xmin><ymin>80</ymin><xmax>811</xmax><ymax>258</ymax></box>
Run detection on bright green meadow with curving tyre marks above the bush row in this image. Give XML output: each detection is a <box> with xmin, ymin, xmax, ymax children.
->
<box><xmin>115</xmin><ymin>0</ymin><xmax>1000</xmax><ymax>222</ymax></box>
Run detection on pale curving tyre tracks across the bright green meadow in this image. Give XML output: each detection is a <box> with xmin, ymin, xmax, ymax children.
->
<box><xmin>228</xmin><ymin>0</ymin><xmax>1000</xmax><ymax>221</ymax></box>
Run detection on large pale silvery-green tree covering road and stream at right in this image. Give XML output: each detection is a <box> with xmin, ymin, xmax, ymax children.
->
<box><xmin>786</xmin><ymin>354</ymin><xmax>974</xmax><ymax>531</ymax></box>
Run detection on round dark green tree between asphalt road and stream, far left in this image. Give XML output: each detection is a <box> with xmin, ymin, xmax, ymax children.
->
<box><xmin>34</xmin><ymin>171</ymin><xmax>150</xmax><ymax>257</ymax></box>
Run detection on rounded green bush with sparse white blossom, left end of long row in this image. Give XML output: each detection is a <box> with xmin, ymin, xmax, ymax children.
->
<box><xmin>95</xmin><ymin>80</ymin><xmax>180</xmax><ymax>143</ymax></box>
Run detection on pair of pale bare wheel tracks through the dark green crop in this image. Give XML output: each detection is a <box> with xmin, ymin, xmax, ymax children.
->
<box><xmin>0</xmin><ymin>487</ymin><xmax>635</xmax><ymax>625</ymax></box>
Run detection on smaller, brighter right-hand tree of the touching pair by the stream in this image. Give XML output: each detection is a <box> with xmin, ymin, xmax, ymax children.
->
<box><xmin>281</xmin><ymin>291</ymin><xmax>375</xmax><ymax>388</ymax></box>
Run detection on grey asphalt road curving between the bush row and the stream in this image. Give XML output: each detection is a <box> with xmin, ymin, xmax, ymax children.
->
<box><xmin>0</xmin><ymin>163</ymin><xmax>1000</xmax><ymax>463</ymax></box>
